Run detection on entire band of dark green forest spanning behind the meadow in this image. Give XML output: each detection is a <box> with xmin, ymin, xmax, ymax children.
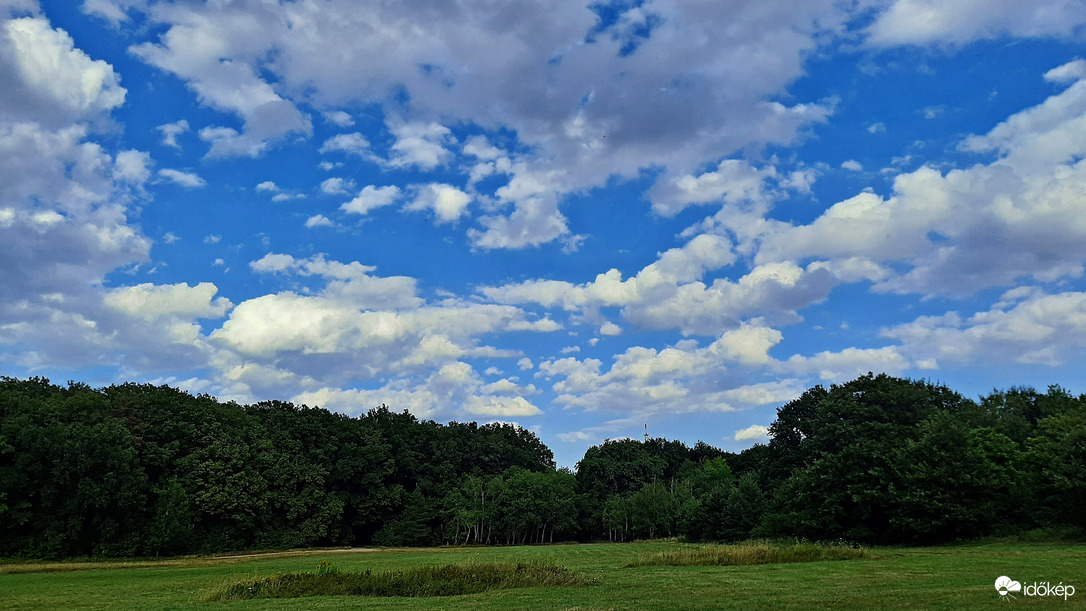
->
<box><xmin>0</xmin><ymin>374</ymin><xmax>1086</xmax><ymax>558</ymax></box>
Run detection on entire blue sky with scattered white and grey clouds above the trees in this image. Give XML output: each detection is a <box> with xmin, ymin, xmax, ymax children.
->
<box><xmin>0</xmin><ymin>0</ymin><xmax>1086</xmax><ymax>466</ymax></box>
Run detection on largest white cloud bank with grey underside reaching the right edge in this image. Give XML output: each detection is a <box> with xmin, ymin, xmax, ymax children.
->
<box><xmin>756</xmin><ymin>69</ymin><xmax>1086</xmax><ymax>296</ymax></box>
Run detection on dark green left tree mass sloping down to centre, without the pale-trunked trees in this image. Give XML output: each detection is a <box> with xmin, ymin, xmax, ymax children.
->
<box><xmin>0</xmin><ymin>378</ymin><xmax>560</xmax><ymax>558</ymax></box>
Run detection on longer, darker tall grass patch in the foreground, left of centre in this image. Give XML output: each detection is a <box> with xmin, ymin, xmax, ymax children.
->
<box><xmin>209</xmin><ymin>561</ymin><xmax>592</xmax><ymax>601</ymax></box>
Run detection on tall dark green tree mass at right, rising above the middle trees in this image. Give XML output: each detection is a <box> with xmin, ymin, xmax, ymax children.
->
<box><xmin>756</xmin><ymin>374</ymin><xmax>1086</xmax><ymax>543</ymax></box>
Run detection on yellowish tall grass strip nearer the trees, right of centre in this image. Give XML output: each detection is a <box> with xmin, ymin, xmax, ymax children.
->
<box><xmin>627</xmin><ymin>540</ymin><xmax>868</xmax><ymax>567</ymax></box>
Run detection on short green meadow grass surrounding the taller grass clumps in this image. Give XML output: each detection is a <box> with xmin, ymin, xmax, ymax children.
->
<box><xmin>0</xmin><ymin>542</ymin><xmax>1086</xmax><ymax>609</ymax></box>
